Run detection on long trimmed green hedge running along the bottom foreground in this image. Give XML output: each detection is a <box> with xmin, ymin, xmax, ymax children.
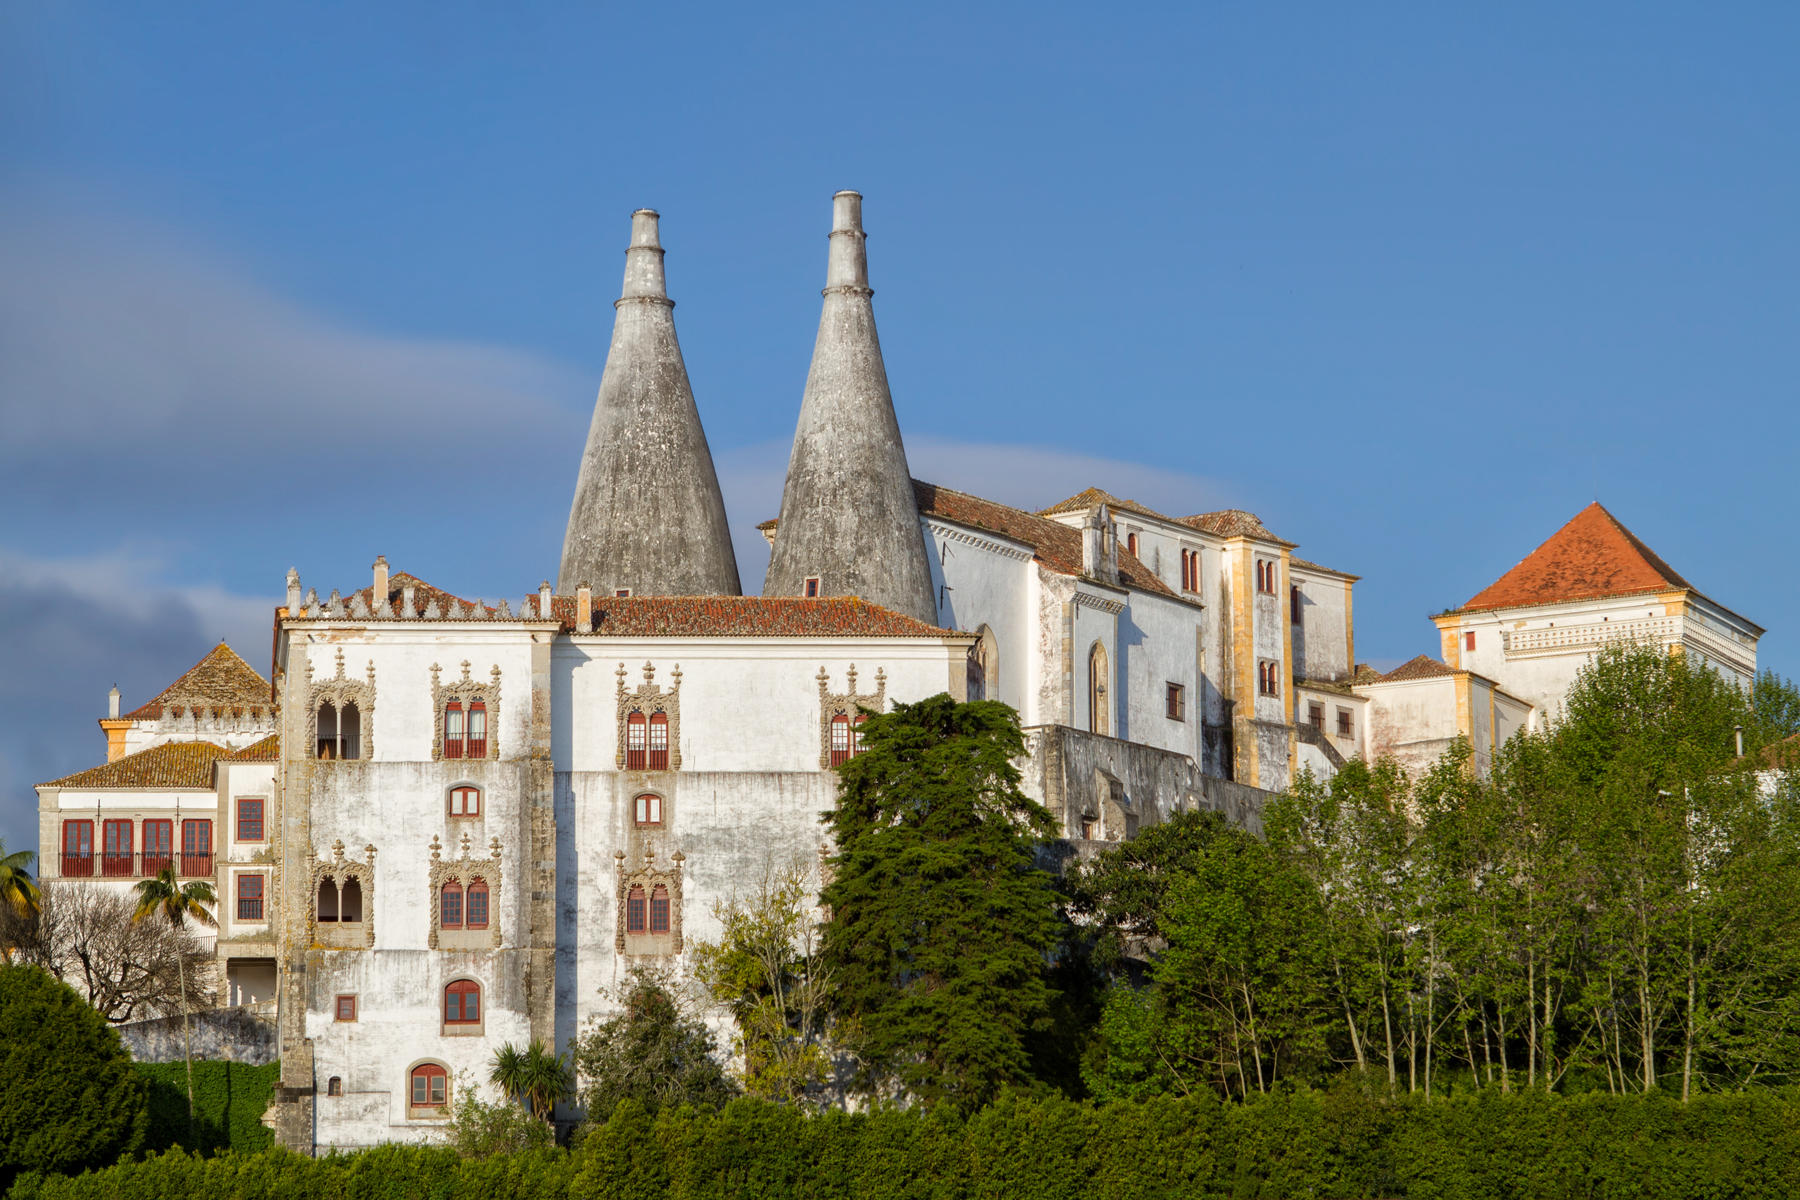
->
<box><xmin>13</xmin><ymin>1088</ymin><xmax>1800</xmax><ymax>1200</ymax></box>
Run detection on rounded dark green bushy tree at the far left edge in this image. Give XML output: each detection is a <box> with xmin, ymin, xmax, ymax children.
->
<box><xmin>0</xmin><ymin>964</ymin><xmax>148</xmax><ymax>1187</ymax></box>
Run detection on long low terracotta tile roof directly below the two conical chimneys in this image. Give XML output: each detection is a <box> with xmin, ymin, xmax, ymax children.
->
<box><xmin>551</xmin><ymin>596</ymin><xmax>954</xmax><ymax>637</ymax></box>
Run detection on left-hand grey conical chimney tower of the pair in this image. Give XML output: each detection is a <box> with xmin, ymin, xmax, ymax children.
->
<box><xmin>556</xmin><ymin>209</ymin><xmax>742</xmax><ymax>596</ymax></box>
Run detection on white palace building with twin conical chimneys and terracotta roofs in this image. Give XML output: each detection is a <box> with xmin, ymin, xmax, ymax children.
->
<box><xmin>38</xmin><ymin>193</ymin><xmax>1760</xmax><ymax>1151</ymax></box>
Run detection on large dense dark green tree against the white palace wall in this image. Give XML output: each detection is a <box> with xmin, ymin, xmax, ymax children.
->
<box><xmin>823</xmin><ymin>694</ymin><xmax>1060</xmax><ymax>1108</ymax></box>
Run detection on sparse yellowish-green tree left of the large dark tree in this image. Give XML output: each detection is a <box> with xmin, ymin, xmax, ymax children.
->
<box><xmin>693</xmin><ymin>864</ymin><xmax>832</xmax><ymax>1103</ymax></box>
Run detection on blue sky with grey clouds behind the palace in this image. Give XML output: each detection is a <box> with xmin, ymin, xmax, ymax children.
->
<box><xmin>0</xmin><ymin>4</ymin><xmax>1800</xmax><ymax>846</ymax></box>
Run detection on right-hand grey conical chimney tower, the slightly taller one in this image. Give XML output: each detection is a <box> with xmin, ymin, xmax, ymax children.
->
<box><xmin>763</xmin><ymin>193</ymin><xmax>938</xmax><ymax>624</ymax></box>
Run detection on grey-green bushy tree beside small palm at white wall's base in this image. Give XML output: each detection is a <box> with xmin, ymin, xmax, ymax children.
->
<box><xmin>569</xmin><ymin>968</ymin><xmax>738</xmax><ymax>1124</ymax></box>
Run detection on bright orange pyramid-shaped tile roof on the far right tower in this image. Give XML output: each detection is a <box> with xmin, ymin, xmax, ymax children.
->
<box><xmin>1453</xmin><ymin>500</ymin><xmax>1694</xmax><ymax>612</ymax></box>
